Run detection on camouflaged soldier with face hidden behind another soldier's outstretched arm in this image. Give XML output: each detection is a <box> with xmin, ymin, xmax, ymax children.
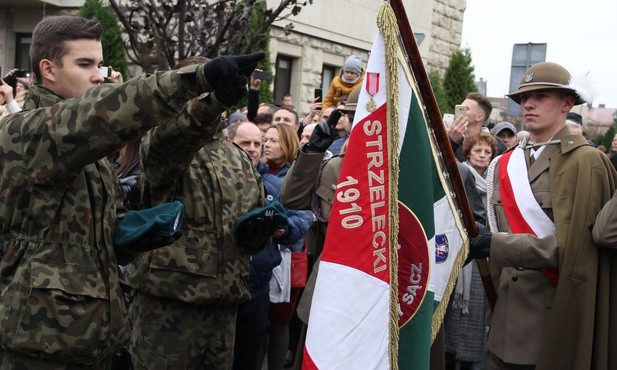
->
<box><xmin>127</xmin><ymin>58</ymin><xmax>271</xmax><ymax>370</ymax></box>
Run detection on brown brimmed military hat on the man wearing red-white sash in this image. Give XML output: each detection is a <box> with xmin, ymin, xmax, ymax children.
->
<box><xmin>508</xmin><ymin>62</ymin><xmax>585</xmax><ymax>105</ymax></box>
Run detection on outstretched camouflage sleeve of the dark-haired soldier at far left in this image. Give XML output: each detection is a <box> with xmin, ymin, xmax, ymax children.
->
<box><xmin>10</xmin><ymin>65</ymin><xmax>211</xmax><ymax>183</ymax></box>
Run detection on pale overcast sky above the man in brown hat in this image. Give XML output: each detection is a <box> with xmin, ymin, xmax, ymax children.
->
<box><xmin>461</xmin><ymin>0</ymin><xmax>617</xmax><ymax>108</ymax></box>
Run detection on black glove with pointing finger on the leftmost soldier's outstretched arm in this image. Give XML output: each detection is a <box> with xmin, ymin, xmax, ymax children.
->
<box><xmin>204</xmin><ymin>52</ymin><xmax>266</xmax><ymax>107</ymax></box>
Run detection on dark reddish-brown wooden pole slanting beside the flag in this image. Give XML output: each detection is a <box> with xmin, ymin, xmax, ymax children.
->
<box><xmin>390</xmin><ymin>0</ymin><xmax>497</xmax><ymax>310</ymax></box>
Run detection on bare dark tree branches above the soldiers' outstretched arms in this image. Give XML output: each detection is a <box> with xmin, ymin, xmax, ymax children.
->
<box><xmin>109</xmin><ymin>0</ymin><xmax>313</xmax><ymax>72</ymax></box>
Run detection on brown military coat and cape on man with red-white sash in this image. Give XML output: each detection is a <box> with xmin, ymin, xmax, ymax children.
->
<box><xmin>488</xmin><ymin>128</ymin><xmax>617</xmax><ymax>369</ymax></box>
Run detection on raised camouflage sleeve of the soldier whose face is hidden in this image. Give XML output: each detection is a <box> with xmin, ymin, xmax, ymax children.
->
<box><xmin>141</xmin><ymin>94</ymin><xmax>225</xmax><ymax>206</ymax></box>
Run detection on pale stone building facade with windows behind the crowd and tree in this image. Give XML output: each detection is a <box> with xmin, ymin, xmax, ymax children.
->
<box><xmin>0</xmin><ymin>0</ymin><xmax>466</xmax><ymax>113</ymax></box>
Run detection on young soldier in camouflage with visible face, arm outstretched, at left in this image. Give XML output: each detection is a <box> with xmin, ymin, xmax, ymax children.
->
<box><xmin>0</xmin><ymin>16</ymin><xmax>263</xmax><ymax>369</ymax></box>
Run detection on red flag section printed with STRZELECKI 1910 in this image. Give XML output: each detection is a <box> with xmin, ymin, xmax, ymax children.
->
<box><xmin>321</xmin><ymin>104</ymin><xmax>390</xmax><ymax>283</ymax></box>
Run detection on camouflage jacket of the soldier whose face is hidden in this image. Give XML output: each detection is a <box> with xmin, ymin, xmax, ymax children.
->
<box><xmin>127</xmin><ymin>100</ymin><xmax>264</xmax><ymax>304</ymax></box>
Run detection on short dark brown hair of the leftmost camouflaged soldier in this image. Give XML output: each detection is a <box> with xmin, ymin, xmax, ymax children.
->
<box><xmin>30</xmin><ymin>15</ymin><xmax>103</xmax><ymax>81</ymax></box>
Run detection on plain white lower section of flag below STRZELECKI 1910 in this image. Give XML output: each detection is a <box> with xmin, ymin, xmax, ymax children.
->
<box><xmin>306</xmin><ymin>261</ymin><xmax>390</xmax><ymax>369</ymax></box>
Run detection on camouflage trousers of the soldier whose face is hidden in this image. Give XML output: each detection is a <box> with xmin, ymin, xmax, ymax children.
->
<box><xmin>129</xmin><ymin>292</ymin><xmax>237</xmax><ymax>370</ymax></box>
